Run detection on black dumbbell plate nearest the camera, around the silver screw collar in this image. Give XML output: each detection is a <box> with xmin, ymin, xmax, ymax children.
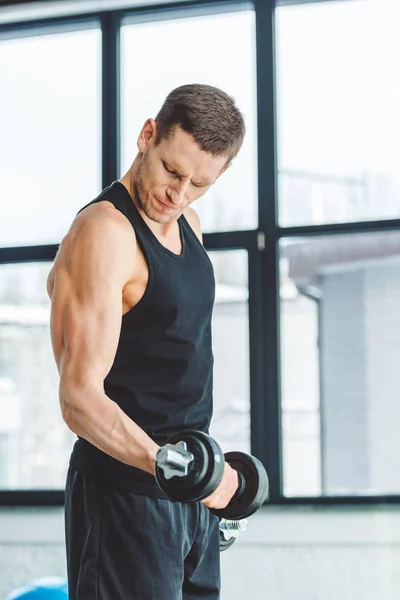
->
<box><xmin>155</xmin><ymin>431</ymin><xmax>224</xmax><ymax>502</ymax></box>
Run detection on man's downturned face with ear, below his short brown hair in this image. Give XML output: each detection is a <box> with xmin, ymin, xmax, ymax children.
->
<box><xmin>134</xmin><ymin>120</ymin><xmax>230</xmax><ymax>223</ymax></box>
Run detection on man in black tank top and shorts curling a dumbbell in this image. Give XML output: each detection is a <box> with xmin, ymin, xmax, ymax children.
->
<box><xmin>48</xmin><ymin>84</ymin><xmax>245</xmax><ymax>600</ymax></box>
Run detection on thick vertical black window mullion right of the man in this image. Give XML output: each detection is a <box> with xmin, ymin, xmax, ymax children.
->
<box><xmin>254</xmin><ymin>0</ymin><xmax>283</xmax><ymax>496</ymax></box>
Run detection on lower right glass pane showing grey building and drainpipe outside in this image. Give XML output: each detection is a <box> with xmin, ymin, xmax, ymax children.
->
<box><xmin>280</xmin><ymin>231</ymin><xmax>400</xmax><ymax>496</ymax></box>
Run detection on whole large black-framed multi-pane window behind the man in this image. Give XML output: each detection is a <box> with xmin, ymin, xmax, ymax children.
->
<box><xmin>0</xmin><ymin>0</ymin><xmax>400</xmax><ymax>504</ymax></box>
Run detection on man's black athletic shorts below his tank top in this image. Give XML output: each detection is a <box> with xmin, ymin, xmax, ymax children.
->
<box><xmin>65</xmin><ymin>467</ymin><xmax>220</xmax><ymax>600</ymax></box>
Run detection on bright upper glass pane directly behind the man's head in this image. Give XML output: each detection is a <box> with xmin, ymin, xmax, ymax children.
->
<box><xmin>121</xmin><ymin>11</ymin><xmax>257</xmax><ymax>231</ymax></box>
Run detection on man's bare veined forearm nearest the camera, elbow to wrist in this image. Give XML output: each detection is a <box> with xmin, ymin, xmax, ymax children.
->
<box><xmin>60</xmin><ymin>390</ymin><xmax>159</xmax><ymax>474</ymax></box>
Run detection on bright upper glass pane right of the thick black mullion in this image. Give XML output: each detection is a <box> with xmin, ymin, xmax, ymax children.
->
<box><xmin>276</xmin><ymin>0</ymin><xmax>400</xmax><ymax>226</ymax></box>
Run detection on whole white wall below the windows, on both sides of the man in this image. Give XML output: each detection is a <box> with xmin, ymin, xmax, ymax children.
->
<box><xmin>0</xmin><ymin>506</ymin><xmax>400</xmax><ymax>600</ymax></box>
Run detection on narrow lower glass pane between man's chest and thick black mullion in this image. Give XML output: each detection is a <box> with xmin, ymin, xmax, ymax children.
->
<box><xmin>209</xmin><ymin>250</ymin><xmax>250</xmax><ymax>453</ymax></box>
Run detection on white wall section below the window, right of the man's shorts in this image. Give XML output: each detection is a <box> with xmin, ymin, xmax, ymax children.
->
<box><xmin>222</xmin><ymin>507</ymin><xmax>400</xmax><ymax>600</ymax></box>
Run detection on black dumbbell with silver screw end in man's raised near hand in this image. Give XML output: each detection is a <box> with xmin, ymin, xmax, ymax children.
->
<box><xmin>155</xmin><ymin>430</ymin><xmax>268</xmax><ymax>520</ymax></box>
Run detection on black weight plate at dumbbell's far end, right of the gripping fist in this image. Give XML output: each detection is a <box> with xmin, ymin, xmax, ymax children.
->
<box><xmin>212</xmin><ymin>452</ymin><xmax>269</xmax><ymax>519</ymax></box>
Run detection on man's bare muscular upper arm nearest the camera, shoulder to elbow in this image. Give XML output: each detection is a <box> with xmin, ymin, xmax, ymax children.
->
<box><xmin>50</xmin><ymin>213</ymin><xmax>133</xmax><ymax>389</ymax></box>
